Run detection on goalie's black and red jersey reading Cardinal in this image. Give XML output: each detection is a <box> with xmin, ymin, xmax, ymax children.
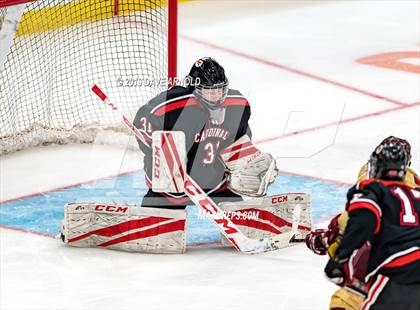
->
<box><xmin>133</xmin><ymin>86</ymin><xmax>251</xmax><ymax>191</ymax></box>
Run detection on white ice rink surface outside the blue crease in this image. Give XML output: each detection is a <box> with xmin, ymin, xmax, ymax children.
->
<box><xmin>0</xmin><ymin>1</ymin><xmax>420</xmax><ymax>310</ymax></box>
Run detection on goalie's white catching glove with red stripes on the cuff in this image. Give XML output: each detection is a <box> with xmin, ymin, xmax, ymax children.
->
<box><xmin>222</xmin><ymin>135</ymin><xmax>278</xmax><ymax>197</ymax></box>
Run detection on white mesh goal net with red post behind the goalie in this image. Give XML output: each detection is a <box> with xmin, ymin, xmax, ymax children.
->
<box><xmin>0</xmin><ymin>0</ymin><xmax>178</xmax><ymax>154</ymax></box>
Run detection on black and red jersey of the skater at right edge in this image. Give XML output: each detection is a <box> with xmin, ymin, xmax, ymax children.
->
<box><xmin>337</xmin><ymin>179</ymin><xmax>420</xmax><ymax>284</ymax></box>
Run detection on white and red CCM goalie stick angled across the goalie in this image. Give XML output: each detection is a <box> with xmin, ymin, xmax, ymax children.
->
<box><xmin>92</xmin><ymin>85</ymin><xmax>300</xmax><ymax>254</ymax></box>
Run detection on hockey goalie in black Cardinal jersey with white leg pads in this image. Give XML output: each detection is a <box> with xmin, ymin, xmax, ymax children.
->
<box><xmin>62</xmin><ymin>57</ymin><xmax>311</xmax><ymax>253</ymax></box>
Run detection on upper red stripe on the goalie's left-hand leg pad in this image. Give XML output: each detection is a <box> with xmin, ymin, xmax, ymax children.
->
<box><xmin>69</xmin><ymin>217</ymin><xmax>170</xmax><ymax>242</ymax></box>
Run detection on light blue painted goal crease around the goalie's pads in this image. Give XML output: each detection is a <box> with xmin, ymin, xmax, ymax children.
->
<box><xmin>0</xmin><ymin>173</ymin><xmax>348</xmax><ymax>244</ymax></box>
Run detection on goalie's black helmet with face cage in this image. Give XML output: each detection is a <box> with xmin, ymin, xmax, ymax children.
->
<box><xmin>187</xmin><ymin>57</ymin><xmax>229</xmax><ymax>108</ymax></box>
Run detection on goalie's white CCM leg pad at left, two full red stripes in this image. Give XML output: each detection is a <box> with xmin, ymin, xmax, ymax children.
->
<box><xmin>61</xmin><ymin>203</ymin><xmax>187</xmax><ymax>253</ymax></box>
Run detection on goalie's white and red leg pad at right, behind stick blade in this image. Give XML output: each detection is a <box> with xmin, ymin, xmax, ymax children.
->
<box><xmin>220</xmin><ymin>193</ymin><xmax>312</xmax><ymax>245</ymax></box>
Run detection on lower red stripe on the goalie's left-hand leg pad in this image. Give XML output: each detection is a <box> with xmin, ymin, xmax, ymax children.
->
<box><xmin>99</xmin><ymin>220</ymin><xmax>185</xmax><ymax>247</ymax></box>
